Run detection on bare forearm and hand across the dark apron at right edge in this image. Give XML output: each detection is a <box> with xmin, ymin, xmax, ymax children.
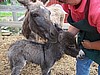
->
<box><xmin>82</xmin><ymin>40</ymin><xmax>100</xmax><ymax>50</ymax></box>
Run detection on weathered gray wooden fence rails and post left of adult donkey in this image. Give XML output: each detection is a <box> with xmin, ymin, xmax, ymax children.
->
<box><xmin>0</xmin><ymin>5</ymin><xmax>26</xmax><ymax>27</ymax></box>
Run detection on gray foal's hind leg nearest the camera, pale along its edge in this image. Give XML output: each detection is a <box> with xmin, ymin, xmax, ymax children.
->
<box><xmin>11</xmin><ymin>57</ymin><xmax>26</xmax><ymax>75</ymax></box>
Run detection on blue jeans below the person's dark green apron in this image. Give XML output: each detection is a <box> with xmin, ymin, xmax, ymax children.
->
<box><xmin>76</xmin><ymin>57</ymin><xmax>100</xmax><ymax>75</ymax></box>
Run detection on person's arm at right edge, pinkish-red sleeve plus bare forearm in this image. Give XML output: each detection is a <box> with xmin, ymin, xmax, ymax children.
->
<box><xmin>82</xmin><ymin>1</ymin><xmax>100</xmax><ymax>50</ymax></box>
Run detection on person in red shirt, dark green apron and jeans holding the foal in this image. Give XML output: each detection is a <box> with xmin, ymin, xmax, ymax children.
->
<box><xmin>58</xmin><ymin>0</ymin><xmax>100</xmax><ymax>75</ymax></box>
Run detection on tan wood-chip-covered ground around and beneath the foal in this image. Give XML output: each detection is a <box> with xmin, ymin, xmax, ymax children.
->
<box><xmin>0</xmin><ymin>36</ymin><xmax>98</xmax><ymax>75</ymax></box>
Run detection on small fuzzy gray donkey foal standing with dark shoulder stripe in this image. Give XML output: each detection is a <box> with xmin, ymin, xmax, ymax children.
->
<box><xmin>8</xmin><ymin>31</ymin><xmax>78</xmax><ymax>75</ymax></box>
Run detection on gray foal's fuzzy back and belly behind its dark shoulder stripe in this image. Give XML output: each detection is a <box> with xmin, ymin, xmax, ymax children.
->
<box><xmin>8</xmin><ymin>40</ymin><xmax>43</xmax><ymax>65</ymax></box>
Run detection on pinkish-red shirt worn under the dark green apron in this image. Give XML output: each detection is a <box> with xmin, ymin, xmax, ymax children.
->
<box><xmin>62</xmin><ymin>0</ymin><xmax>100</xmax><ymax>33</ymax></box>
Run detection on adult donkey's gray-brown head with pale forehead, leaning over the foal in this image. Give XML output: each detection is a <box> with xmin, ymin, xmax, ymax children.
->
<box><xmin>18</xmin><ymin>0</ymin><xmax>58</xmax><ymax>42</ymax></box>
